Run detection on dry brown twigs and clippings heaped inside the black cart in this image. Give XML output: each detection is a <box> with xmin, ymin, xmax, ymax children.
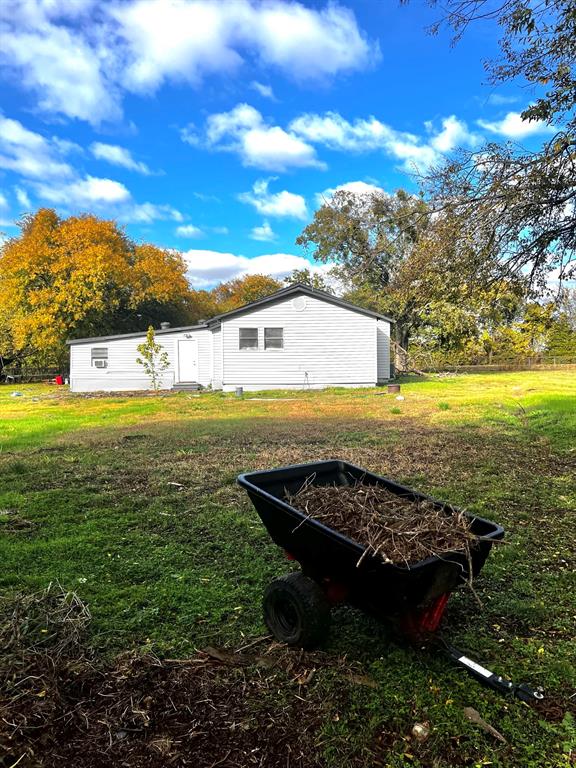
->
<box><xmin>287</xmin><ymin>478</ymin><xmax>478</xmax><ymax>566</ymax></box>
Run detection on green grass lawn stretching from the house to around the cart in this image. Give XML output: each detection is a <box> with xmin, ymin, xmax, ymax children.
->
<box><xmin>0</xmin><ymin>371</ymin><xmax>576</xmax><ymax>768</ymax></box>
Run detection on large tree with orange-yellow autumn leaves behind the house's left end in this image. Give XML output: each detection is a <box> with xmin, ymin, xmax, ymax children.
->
<box><xmin>0</xmin><ymin>209</ymin><xmax>194</xmax><ymax>365</ymax></box>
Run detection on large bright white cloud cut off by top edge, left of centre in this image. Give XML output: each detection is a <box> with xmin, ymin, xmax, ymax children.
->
<box><xmin>111</xmin><ymin>0</ymin><xmax>378</xmax><ymax>91</ymax></box>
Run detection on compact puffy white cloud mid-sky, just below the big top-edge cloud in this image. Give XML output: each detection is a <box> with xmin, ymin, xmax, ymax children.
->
<box><xmin>200</xmin><ymin>104</ymin><xmax>324</xmax><ymax>171</ymax></box>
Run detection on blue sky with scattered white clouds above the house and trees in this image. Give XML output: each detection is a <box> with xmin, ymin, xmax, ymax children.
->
<box><xmin>0</xmin><ymin>0</ymin><xmax>552</xmax><ymax>288</ymax></box>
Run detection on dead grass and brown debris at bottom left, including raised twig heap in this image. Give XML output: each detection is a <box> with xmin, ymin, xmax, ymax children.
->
<box><xmin>0</xmin><ymin>584</ymin><xmax>322</xmax><ymax>768</ymax></box>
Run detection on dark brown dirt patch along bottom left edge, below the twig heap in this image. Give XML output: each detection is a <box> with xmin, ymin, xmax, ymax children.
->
<box><xmin>0</xmin><ymin>654</ymin><xmax>321</xmax><ymax>768</ymax></box>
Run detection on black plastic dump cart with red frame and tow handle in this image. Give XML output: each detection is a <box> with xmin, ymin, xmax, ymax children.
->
<box><xmin>238</xmin><ymin>459</ymin><xmax>543</xmax><ymax>701</ymax></box>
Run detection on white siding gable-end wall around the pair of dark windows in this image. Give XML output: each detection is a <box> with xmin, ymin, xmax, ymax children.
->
<box><xmin>222</xmin><ymin>296</ymin><xmax>378</xmax><ymax>390</ymax></box>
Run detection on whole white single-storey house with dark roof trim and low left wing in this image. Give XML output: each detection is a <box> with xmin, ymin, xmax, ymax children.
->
<box><xmin>68</xmin><ymin>284</ymin><xmax>391</xmax><ymax>392</ymax></box>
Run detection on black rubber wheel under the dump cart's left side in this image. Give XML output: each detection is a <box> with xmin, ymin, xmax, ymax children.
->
<box><xmin>263</xmin><ymin>571</ymin><xmax>330</xmax><ymax>649</ymax></box>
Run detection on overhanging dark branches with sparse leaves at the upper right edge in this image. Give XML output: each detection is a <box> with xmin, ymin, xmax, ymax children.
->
<box><xmin>414</xmin><ymin>0</ymin><xmax>576</xmax><ymax>288</ymax></box>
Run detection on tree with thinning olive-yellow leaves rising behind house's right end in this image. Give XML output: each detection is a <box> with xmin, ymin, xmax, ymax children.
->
<box><xmin>297</xmin><ymin>190</ymin><xmax>521</xmax><ymax>349</ymax></box>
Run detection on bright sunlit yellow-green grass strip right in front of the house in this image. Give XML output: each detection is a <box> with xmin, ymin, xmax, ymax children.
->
<box><xmin>0</xmin><ymin>370</ymin><xmax>576</xmax><ymax>450</ymax></box>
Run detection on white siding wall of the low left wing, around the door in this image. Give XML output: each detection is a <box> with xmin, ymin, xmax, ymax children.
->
<box><xmin>70</xmin><ymin>329</ymin><xmax>212</xmax><ymax>392</ymax></box>
